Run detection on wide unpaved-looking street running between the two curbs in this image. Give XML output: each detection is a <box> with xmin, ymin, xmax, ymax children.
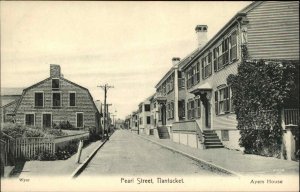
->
<box><xmin>79</xmin><ymin>130</ymin><xmax>220</xmax><ymax>177</ymax></box>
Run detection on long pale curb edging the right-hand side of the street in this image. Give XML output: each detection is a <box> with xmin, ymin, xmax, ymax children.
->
<box><xmin>137</xmin><ymin>135</ymin><xmax>242</xmax><ymax>177</ymax></box>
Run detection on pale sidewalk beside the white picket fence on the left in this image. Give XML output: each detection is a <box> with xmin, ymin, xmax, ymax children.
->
<box><xmin>19</xmin><ymin>141</ymin><xmax>103</xmax><ymax>178</ymax></box>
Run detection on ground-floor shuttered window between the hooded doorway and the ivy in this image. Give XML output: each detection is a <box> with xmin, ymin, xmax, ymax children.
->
<box><xmin>215</xmin><ymin>87</ymin><xmax>231</xmax><ymax>114</ymax></box>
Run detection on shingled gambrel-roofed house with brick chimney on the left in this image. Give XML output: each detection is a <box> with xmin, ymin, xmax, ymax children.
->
<box><xmin>15</xmin><ymin>64</ymin><xmax>100</xmax><ymax>132</ymax></box>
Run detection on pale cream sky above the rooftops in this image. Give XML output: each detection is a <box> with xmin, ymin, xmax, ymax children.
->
<box><xmin>0</xmin><ymin>1</ymin><xmax>251</xmax><ymax>119</ymax></box>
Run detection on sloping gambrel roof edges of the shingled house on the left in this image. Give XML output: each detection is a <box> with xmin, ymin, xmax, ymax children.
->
<box><xmin>14</xmin><ymin>77</ymin><xmax>100</xmax><ymax>113</ymax></box>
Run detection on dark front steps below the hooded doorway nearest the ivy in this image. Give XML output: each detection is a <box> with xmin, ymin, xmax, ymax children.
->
<box><xmin>202</xmin><ymin>130</ymin><xmax>224</xmax><ymax>149</ymax></box>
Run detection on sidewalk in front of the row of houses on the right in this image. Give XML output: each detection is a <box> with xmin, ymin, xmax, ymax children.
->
<box><xmin>137</xmin><ymin>134</ymin><xmax>299</xmax><ymax>176</ymax></box>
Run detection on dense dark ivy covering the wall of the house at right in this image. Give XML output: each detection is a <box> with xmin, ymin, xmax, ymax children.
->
<box><xmin>227</xmin><ymin>57</ymin><xmax>299</xmax><ymax>157</ymax></box>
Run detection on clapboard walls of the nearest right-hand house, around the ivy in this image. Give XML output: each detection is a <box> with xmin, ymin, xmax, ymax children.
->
<box><xmin>181</xmin><ymin>1</ymin><xmax>299</xmax><ymax>153</ymax></box>
